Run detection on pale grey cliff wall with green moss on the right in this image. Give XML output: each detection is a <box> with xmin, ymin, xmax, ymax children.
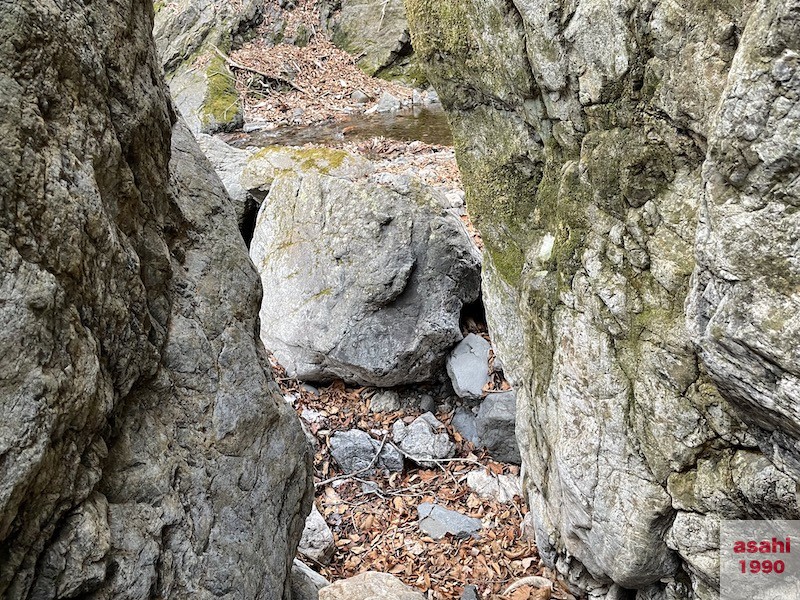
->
<box><xmin>406</xmin><ymin>0</ymin><xmax>800</xmax><ymax>599</ymax></box>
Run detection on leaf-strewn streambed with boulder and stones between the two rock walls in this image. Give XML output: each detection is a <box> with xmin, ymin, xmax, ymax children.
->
<box><xmin>198</xmin><ymin>101</ymin><xmax>570</xmax><ymax>599</ymax></box>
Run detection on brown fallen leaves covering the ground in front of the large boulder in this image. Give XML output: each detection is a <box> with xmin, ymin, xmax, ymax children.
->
<box><xmin>272</xmin><ymin>357</ymin><xmax>573</xmax><ymax>600</ymax></box>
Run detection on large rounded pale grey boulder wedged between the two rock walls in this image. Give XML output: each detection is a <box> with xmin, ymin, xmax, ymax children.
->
<box><xmin>250</xmin><ymin>171</ymin><xmax>480</xmax><ymax>387</ymax></box>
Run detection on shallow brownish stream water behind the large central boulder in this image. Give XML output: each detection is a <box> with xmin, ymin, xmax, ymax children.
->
<box><xmin>234</xmin><ymin>106</ymin><xmax>453</xmax><ymax>148</ymax></box>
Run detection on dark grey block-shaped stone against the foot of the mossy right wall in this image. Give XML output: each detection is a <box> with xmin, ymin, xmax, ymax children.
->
<box><xmin>475</xmin><ymin>391</ymin><xmax>522</xmax><ymax>465</ymax></box>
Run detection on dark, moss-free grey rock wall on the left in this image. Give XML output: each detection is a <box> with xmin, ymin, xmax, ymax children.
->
<box><xmin>0</xmin><ymin>0</ymin><xmax>311</xmax><ymax>600</ymax></box>
